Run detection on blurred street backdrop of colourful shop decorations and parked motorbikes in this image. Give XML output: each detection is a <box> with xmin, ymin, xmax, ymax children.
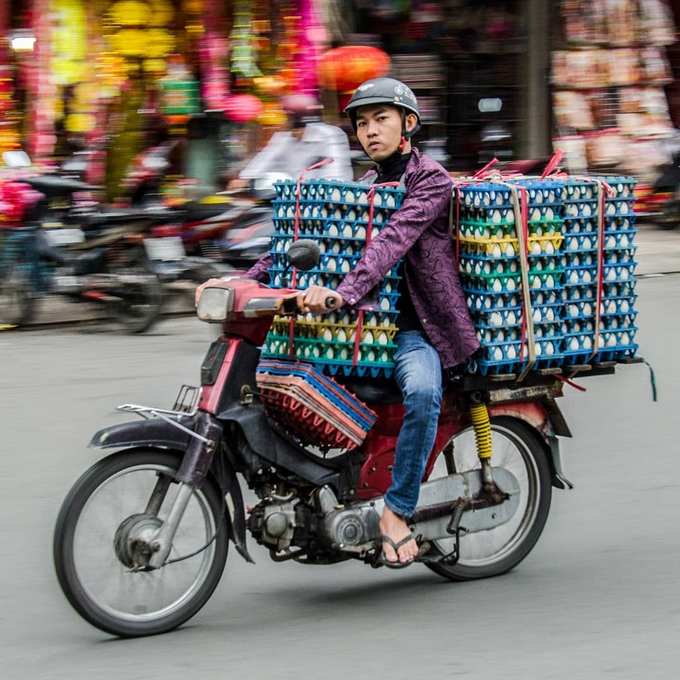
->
<box><xmin>0</xmin><ymin>0</ymin><xmax>680</xmax><ymax>331</ymax></box>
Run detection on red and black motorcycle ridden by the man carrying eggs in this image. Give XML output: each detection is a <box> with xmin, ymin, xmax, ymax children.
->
<box><xmin>53</xmin><ymin>240</ymin><xmax>571</xmax><ymax>637</ymax></box>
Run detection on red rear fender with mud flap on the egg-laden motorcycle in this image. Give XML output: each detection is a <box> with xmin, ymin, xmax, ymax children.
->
<box><xmin>489</xmin><ymin>397</ymin><xmax>574</xmax><ymax>489</ymax></box>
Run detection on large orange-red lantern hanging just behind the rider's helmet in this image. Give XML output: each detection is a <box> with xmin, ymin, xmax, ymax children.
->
<box><xmin>319</xmin><ymin>45</ymin><xmax>390</xmax><ymax>92</ymax></box>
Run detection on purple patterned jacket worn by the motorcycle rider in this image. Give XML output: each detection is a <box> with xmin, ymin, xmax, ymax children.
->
<box><xmin>247</xmin><ymin>149</ymin><xmax>479</xmax><ymax>368</ymax></box>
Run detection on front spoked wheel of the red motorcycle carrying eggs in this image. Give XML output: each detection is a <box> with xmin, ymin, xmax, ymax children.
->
<box><xmin>54</xmin><ymin>450</ymin><xmax>228</xmax><ymax>637</ymax></box>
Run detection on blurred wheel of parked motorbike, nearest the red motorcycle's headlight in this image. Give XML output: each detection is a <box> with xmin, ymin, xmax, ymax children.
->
<box><xmin>114</xmin><ymin>253</ymin><xmax>164</xmax><ymax>334</ymax></box>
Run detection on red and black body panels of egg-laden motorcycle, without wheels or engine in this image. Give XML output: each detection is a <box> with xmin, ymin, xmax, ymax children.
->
<box><xmin>90</xmin><ymin>279</ymin><xmax>571</xmax><ymax>561</ymax></box>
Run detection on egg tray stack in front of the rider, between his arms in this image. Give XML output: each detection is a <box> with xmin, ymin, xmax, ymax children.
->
<box><xmin>263</xmin><ymin>180</ymin><xmax>404</xmax><ymax>377</ymax></box>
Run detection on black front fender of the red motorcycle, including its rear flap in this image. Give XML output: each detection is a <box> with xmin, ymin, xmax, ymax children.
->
<box><xmin>89</xmin><ymin>418</ymin><xmax>255</xmax><ymax>563</ymax></box>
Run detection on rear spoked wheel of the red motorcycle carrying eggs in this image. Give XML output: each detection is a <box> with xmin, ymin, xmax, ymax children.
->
<box><xmin>426</xmin><ymin>417</ymin><xmax>552</xmax><ymax>581</ymax></box>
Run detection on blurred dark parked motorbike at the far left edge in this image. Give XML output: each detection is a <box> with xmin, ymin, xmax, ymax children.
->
<box><xmin>0</xmin><ymin>175</ymin><xmax>167</xmax><ymax>333</ymax></box>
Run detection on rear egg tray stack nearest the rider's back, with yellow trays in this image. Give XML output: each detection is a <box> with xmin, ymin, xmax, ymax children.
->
<box><xmin>458</xmin><ymin>180</ymin><xmax>564</xmax><ymax>375</ymax></box>
